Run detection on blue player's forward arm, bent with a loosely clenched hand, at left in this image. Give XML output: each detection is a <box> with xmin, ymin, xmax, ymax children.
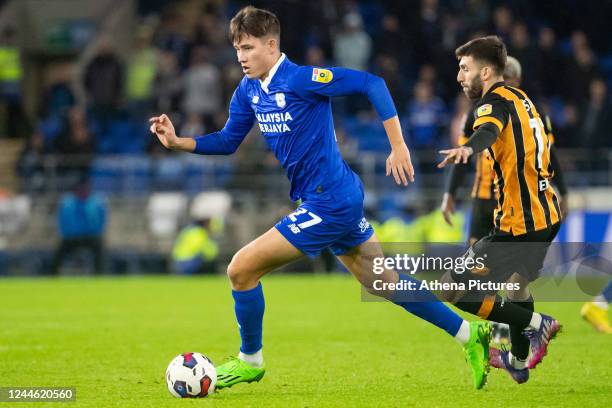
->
<box><xmin>149</xmin><ymin>86</ymin><xmax>255</xmax><ymax>155</ymax></box>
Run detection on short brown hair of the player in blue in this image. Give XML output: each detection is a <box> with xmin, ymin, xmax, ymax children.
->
<box><xmin>230</xmin><ymin>6</ymin><xmax>280</xmax><ymax>44</ymax></box>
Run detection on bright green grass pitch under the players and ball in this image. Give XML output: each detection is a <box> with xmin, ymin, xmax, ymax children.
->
<box><xmin>0</xmin><ymin>275</ymin><xmax>612</xmax><ymax>408</ymax></box>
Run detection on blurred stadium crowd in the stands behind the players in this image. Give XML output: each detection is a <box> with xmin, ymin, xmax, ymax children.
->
<box><xmin>0</xmin><ymin>0</ymin><xmax>612</xmax><ymax>195</ymax></box>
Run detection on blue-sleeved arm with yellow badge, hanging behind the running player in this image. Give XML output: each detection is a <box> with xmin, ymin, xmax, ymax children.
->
<box><xmin>290</xmin><ymin>67</ymin><xmax>414</xmax><ymax>185</ymax></box>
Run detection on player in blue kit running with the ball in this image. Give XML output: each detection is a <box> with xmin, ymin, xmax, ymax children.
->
<box><xmin>150</xmin><ymin>6</ymin><xmax>490</xmax><ymax>388</ymax></box>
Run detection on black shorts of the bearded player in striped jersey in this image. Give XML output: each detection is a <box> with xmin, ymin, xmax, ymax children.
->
<box><xmin>452</xmin><ymin>223</ymin><xmax>561</xmax><ymax>282</ymax></box>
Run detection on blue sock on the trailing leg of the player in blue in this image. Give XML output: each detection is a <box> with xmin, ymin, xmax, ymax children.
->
<box><xmin>393</xmin><ymin>274</ymin><xmax>463</xmax><ymax>337</ymax></box>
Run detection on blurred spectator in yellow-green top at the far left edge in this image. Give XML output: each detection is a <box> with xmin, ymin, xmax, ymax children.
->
<box><xmin>0</xmin><ymin>26</ymin><xmax>27</xmax><ymax>138</ymax></box>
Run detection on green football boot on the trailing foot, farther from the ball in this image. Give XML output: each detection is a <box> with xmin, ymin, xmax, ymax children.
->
<box><xmin>463</xmin><ymin>322</ymin><xmax>491</xmax><ymax>390</ymax></box>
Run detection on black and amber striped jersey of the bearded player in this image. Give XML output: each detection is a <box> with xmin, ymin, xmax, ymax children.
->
<box><xmin>473</xmin><ymin>82</ymin><xmax>561</xmax><ymax>235</ymax></box>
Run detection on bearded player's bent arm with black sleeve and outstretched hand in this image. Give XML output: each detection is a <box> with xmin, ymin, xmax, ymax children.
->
<box><xmin>438</xmin><ymin>98</ymin><xmax>508</xmax><ymax>168</ymax></box>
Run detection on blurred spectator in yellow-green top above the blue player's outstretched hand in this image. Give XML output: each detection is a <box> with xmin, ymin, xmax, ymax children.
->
<box><xmin>125</xmin><ymin>25</ymin><xmax>157</xmax><ymax>119</ymax></box>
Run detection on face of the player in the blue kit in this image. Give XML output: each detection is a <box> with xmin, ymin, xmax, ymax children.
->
<box><xmin>234</xmin><ymin>35</ymin><xmax>275</xmax><ymax>79</ymax></box>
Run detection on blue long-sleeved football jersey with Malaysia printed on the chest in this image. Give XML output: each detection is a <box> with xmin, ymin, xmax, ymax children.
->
<box><xmin>195</xmin><ymin>54</ymin><xmax>397</xmax><ymax>201</ymax></box>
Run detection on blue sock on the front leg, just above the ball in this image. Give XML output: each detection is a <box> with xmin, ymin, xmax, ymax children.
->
<box><xmin>232</xmin><ymin>282</ymin><xmax>265</xmax><ymax>354</ymax></box>
